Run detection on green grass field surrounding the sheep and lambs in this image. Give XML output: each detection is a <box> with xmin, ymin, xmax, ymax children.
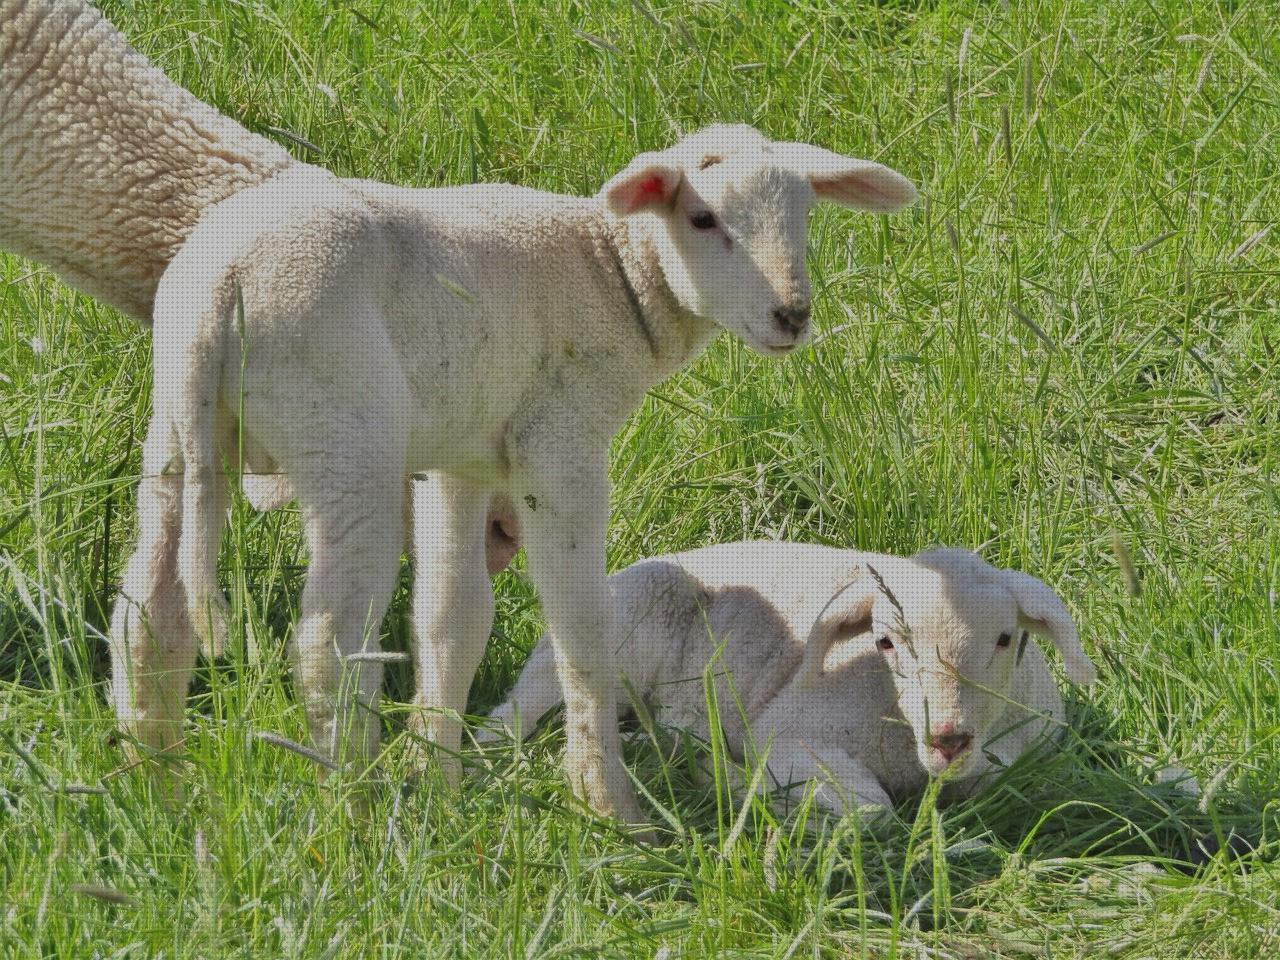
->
<box><xmin>0</xmin><ymin>0</ymin><xmax>1280</xmax><ymax>960</ymax></box>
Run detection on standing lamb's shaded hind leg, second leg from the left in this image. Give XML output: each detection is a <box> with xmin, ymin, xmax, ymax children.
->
<box><xmin>289</xmin><ymin>450</ymin><xmax>404</xmax><ymax>763</ymax></box>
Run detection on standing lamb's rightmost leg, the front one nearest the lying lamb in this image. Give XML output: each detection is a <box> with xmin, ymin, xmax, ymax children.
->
<box><xmin>513</xmin><ymin>458</ymin><xmax>644</xmax><ymax>823</ymax></box>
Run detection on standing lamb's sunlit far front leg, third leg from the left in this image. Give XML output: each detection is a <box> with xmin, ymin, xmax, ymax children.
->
<box><xmin>411</xmin><ymin>474</ymin><xmax>494</xmax><ymax>783</ymax></box>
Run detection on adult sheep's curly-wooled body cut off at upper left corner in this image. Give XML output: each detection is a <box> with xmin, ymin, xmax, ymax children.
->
<box><xmin>0</xmin><ymin>0</ymin><xmax>298</xmax><ymax>324</ymax></box>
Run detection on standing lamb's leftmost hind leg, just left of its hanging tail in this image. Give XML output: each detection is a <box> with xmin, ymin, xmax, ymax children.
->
<box><xmin>110</xmin><ymin>416</ymin><xmax>198</xmax><ymax>756</ymax></box>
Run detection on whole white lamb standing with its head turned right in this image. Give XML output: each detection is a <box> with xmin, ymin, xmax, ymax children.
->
<box><xmin>111</xmin><ymin>120</ymin><xmax>915</xmax><ymax>820</ymax></box>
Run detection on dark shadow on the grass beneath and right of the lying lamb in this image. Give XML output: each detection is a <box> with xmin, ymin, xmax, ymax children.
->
<box><xmin>476</xmin><ymin>703</ymin><xmax>1276</xmax><ymax>929</ymax></box>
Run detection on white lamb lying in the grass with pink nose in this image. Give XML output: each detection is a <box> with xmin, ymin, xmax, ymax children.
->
<box><xmin>484</xmin><ymin>543</ymin><xmax>1094</xmax><ymax>813</ymax></box>
